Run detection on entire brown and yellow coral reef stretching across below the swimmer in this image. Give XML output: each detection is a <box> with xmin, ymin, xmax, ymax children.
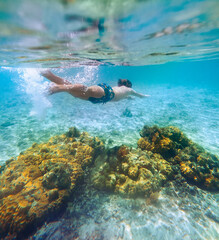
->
<box><xmin>0</xmin><ymin>126</ymin><xmax>219</xmax><ymax>238</ymax></box>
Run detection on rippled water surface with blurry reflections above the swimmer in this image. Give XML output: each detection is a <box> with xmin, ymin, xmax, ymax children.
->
<box><xmin>0</xmin><ymin>0</ymin><xmax>219</xmax><ymax>67</ymax></box>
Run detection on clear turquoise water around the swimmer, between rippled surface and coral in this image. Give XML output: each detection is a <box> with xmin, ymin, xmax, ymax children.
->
<box><xmin>0</xmin><ymin>61</ymin><xmax>219</xmax><ymax>163</ymax></box>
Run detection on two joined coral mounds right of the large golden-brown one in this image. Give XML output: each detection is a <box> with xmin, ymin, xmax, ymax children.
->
<box><xmin>92</xmin><ymin>126</ymin><xmax>219</xmax><ymax>199</ymax></box>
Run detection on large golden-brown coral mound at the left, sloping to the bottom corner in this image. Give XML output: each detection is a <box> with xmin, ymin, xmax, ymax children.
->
<box><xmin>0</xmin><ymin>128</ymin><xmax>103</xmax><ymax>236</ymax></box>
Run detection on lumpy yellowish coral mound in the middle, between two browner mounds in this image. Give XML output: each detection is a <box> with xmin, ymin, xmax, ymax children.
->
<box><xmin>92</xmin><ymin>146</ymin><xmax>173</xmax><ymax>197</ymax></box>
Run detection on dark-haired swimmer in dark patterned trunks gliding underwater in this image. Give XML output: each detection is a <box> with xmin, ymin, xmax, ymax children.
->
<box><xmin>41</xmin><ymin>70</ymin><xmax>150</xmax><ymax>103</ymax></box>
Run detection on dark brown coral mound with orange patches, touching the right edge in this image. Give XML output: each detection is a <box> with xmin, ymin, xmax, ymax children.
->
<box><xmin>138</xmin><ymin>126</ymin><xmax>219</xmax><ymax>191</ymax></box>
